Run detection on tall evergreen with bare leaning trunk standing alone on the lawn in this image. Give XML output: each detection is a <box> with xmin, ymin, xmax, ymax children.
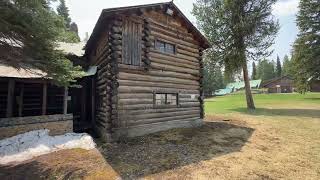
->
<box><xmin>193</xmin><ymin>0</ymin><xmax>279</xmax><ymax>109</ymax></box>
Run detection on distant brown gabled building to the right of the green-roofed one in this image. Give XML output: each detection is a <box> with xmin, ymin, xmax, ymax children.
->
<box><xmin>262</xmin><ymin>76</ymin><xmax>294</xmax><ymax>93</ymax></box>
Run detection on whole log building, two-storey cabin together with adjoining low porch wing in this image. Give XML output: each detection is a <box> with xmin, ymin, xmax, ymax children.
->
<box><xmin>0</xmin><ymin>2</ymin><xmax>209</xmax><ymax>142</ymax></box>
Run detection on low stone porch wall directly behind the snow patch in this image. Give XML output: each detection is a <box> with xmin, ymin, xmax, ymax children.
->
<box><xmin>0</xmin><ymin>114</ymin><xmax>73</xmax><ymax>139</ymax></box>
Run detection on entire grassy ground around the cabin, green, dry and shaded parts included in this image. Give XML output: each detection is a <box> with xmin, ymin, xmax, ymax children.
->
<box><xmin>0</xmin><ymin>93</ymin><xmax>320</xmax><ymax>180</ymax></box>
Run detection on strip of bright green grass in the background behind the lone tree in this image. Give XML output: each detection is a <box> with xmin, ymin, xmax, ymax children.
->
<box><xmin>205</xmin><ymin>93</ymin><xmax>320</xmax><ymax>114</ymax></box>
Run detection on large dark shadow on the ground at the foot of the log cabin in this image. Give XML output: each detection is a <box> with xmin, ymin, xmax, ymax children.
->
<box><xmin>99</xmin><ymin>122</ymin><xmax>254</xmax><ymax>179</ymax></box>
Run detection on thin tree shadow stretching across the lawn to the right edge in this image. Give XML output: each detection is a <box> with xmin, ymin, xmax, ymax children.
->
<box><xmin>231</xmin><ymin>108</ymin><xmax>320</xmax><ymax>118</ymax></box>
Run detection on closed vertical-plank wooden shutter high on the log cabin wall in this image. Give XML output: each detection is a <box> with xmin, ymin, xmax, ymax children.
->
<box><xmin>122</xmin><ymin>19</ymin><xmax>142</xmax><ymax>66</ymax></box>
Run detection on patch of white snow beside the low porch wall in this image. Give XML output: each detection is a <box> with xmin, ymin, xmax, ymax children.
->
<box><xmin>0</xmin><ymin>129</ymin><xmax>96</xmax><ymax>164</ymax></box>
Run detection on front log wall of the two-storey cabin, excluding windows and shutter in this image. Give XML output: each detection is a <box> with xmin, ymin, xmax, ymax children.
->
<box><xmin>116</xmin><ymin>11</ymin><xmax>203</xmax><ymax>136</ymax></box>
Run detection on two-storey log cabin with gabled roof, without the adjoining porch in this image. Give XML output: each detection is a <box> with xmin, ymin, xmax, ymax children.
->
<box><xmin>84</xmin><ymin>2</ymin><xmax>209</xmax><ymax>141</ymax></box>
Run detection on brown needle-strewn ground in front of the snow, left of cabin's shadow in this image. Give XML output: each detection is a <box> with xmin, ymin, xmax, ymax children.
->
<box><xmin>0</xmin><ymin>149</ymin><xmax>117</xmax><ymax>180</ymax></box>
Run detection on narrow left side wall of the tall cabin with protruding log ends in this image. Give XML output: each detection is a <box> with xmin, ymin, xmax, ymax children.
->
<box><xmin>90</xmin><ymin>18</ymin><xmax>122</xmax><ymax>141</ymax></box>
